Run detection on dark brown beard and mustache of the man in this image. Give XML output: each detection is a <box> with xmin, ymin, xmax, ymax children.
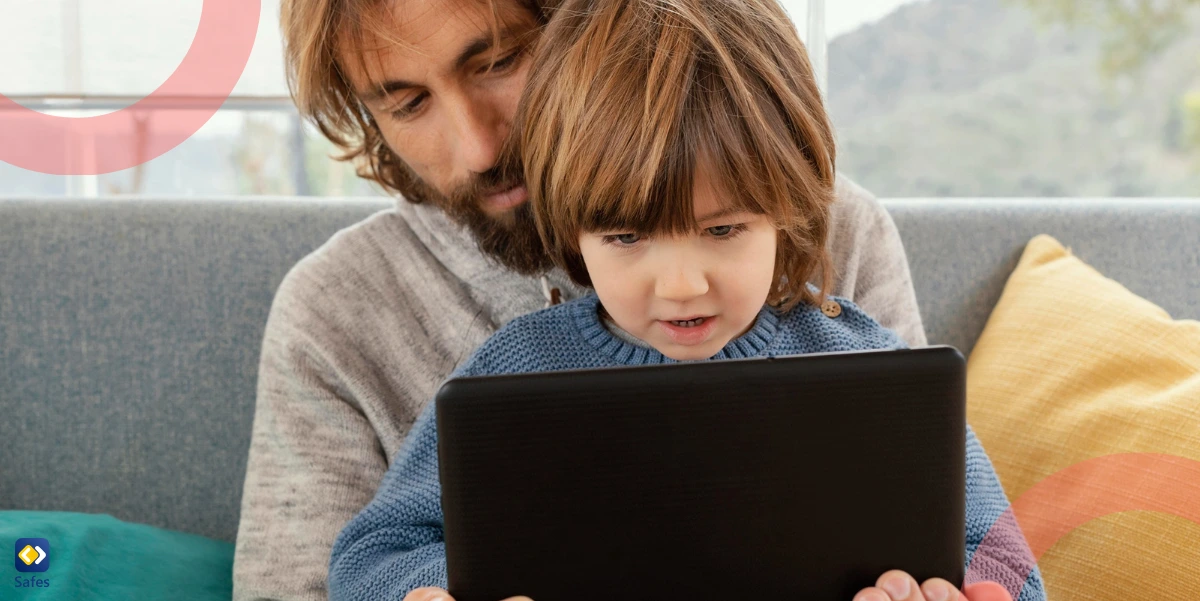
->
<box><xmin>400</xmin><ymin>158</ymin><xmax>553</xmax><ymax>275</ymax></box>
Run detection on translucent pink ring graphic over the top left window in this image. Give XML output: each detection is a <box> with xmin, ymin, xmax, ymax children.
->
<box><xmin>0</xmin><ymin>0</ymin><xmax>260</xmax><ymax>175</ymax></box>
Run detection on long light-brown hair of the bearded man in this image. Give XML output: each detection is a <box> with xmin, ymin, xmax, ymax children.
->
<box><xmin>280</xmin><ymin>0</ymin><xmax>549</xmax><ymax>194</ymax></box>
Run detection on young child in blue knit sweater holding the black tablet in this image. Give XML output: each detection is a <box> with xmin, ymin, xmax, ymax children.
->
<box><xmin>330</xmin><ymin>0</ymin><xmax>1044</xmax><ymax>601</ymax></box>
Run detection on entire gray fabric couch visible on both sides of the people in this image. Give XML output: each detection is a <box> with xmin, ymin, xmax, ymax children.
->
<box><xmin>0</xmin><ymin>199</ymin><xmax>1200</xmax><ymax>541</ymax></box>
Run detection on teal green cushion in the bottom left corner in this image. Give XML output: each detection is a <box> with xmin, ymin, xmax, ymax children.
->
<box><xmin>0</xmin><ymin>511</ymin><xmax>233</xmax><ymax>601</ymax></box>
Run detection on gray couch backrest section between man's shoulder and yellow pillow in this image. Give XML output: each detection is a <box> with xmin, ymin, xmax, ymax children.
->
<box><xmin>884</xmin><ymin>198</ymin><xmax>1200</xmax><ymax>354</ymax></box>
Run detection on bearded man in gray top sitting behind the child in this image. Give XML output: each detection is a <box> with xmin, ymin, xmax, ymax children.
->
<box><xmin>234</xmin><ymin>0</ymin><xmax>925</xmax><ymax>600</ymax></box>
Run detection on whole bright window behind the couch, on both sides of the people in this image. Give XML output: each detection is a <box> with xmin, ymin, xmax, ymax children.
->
<box><xmin>0</xmin><ymin>0</ymin><xmax>1200</xmax><ymax>197</ymax></box>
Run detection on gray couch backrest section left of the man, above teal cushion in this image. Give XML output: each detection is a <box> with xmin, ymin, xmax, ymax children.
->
<box><xmin>0</xmin><ymin>199</ymin><xmax>391</xmax><ymax>541</ymax></box>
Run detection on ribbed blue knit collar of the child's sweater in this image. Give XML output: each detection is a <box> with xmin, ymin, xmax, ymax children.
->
<box><xmin>570</xmin><ymin>294</ymin><xmax>779</xmax><ymax>366</ymax></box>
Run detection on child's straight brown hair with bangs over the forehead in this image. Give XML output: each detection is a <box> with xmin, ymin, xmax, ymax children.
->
<box><xmin>514</xmin><ymin>0</ymin><xmax>835</xmax><ymax>309</ymax></box>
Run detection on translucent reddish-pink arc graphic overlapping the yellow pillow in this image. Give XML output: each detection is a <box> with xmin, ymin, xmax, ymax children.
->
<box><xmin>965</xmin><ymin>453</ymin><xmax>1200</xmax><ymax>599</ymax></box>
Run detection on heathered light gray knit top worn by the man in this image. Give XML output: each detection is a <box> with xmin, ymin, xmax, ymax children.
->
<box><xmin>234</xmin><ymin>180</ymin><xmax>925</xmax><ymax>601</ymax></box>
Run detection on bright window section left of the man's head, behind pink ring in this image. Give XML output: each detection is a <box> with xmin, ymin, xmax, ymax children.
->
<box><xmin>0</xmin><ymin>0</ymin><xmax>378</xmax><ymax>197</ymax></box>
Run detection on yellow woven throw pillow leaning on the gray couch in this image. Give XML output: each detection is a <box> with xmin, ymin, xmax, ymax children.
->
<box><xmin>967</xmin><ymin>235</ymin><xmax>1200</xmax><ymax>601</ymax></box>
